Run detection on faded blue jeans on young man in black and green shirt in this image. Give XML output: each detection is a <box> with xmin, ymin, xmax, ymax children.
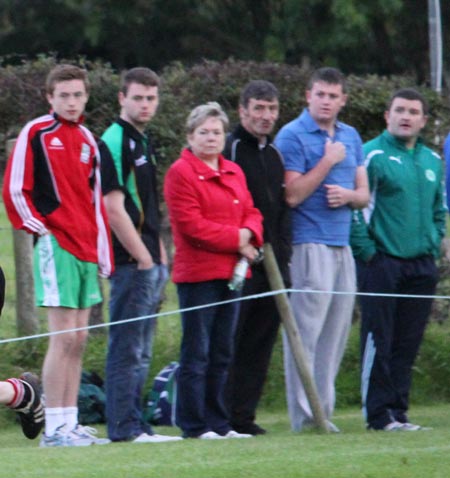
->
<box><xmin>106</xmin><ymin>264</ymin><xmax>168</xmax><ymax>441</ymax></box>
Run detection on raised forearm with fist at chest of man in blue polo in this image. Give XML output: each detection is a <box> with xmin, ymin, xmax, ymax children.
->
<box><xmin>285</xmin><ymin>140</ymin><xmax>345</xmax><ymax>207</ymax></box>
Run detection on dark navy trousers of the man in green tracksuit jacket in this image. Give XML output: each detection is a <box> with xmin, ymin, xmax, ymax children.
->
<box><xmin>357</xmin><ymin>253</ymin><xmax>438</xmax><ymax>429</ymax></box>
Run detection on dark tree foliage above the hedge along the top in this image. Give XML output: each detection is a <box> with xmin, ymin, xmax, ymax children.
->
<box><xmin>0</xmin><ymin>0</ymin><xmax>450</xmax><ymax>83</ymax></box>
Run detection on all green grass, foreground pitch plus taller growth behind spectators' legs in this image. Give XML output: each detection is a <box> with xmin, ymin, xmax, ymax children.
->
<box><xmin>0</xmin><ymin>199</ymin><xmax>450</xmax><ymax>478</ymax></box>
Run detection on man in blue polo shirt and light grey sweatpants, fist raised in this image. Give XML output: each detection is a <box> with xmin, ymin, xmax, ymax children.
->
<box><xmin>275</xmin><ymin>68</ymin><xmax>369</xmax><ymax>431</ymax></box>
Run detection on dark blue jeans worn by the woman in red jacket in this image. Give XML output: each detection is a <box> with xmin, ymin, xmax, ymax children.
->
<box><xmin>177</xmin><ymin>280</ymin><xmax>239</xmax><ymax>437</ymax></box>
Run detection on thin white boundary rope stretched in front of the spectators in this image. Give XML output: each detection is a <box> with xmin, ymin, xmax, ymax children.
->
<box><xmin>0</xmin><ymin>289</ymin><xmax>450</xmax><ymax>345</ymax></box>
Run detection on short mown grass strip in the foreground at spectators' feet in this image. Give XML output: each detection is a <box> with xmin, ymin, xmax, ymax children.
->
<box><xmin>0</xmin><ymin>405</ymin><xmax>450</xmax><ymax>478</ymax></box>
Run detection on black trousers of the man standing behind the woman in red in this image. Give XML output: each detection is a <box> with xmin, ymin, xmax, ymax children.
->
<box><xmin>227</xmin><ymin>264</ymin><xmax>280</xmax><ymax>427</ymax></box>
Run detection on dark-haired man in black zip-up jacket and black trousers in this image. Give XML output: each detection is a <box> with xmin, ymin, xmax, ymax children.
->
<box><xmin>224</xmin><ymin>80</ymin><xmax>291</xmax><ymax>435</ymax></box>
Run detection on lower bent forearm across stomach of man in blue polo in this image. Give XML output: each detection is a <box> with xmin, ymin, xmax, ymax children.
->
<box><xmin>325</xmin><ymin>166</ymin><xmax>370</xmax><ymax>209</ymax></box>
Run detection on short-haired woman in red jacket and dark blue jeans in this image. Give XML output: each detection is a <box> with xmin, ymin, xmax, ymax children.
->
<box><xmin>164</xmin><ymin>102</ymin><xmax>262</xmax><ymax>439</ymax></box>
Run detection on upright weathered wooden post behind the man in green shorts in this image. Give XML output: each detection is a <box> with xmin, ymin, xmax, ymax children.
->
<box><xmin>6</xmin><ymin>140</ymin><xmax>39</xmax><ymax>336</ymax></box>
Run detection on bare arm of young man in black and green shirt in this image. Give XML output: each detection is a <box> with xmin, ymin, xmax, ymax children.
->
<box><xmin>104</xmin><ymin>190</ymin><xmax>153</xmax><ymax>269</ymax></box>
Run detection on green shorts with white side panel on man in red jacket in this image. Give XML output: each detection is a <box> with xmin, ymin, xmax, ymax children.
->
<box><xmin>34</xmin><ymin>234</ymin><xmax>102</xmax><ymax>309</ymax></box>
